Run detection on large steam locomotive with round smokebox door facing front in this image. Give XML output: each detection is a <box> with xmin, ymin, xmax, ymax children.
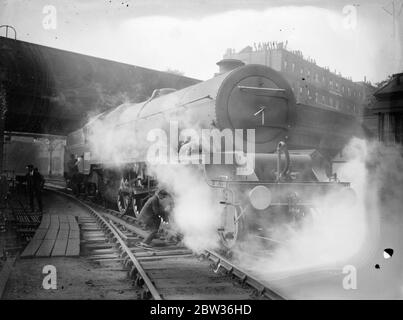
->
<box><xmin>66</xmin><ymin>65</ymin><xmax>358</xmax><ymax>247</ymax></box>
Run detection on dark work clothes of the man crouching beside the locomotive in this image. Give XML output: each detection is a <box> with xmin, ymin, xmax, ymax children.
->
<box><xmin>139</xmin><ymin>195</ymin><xmax>168</xmax><ymax>244</ymax></box>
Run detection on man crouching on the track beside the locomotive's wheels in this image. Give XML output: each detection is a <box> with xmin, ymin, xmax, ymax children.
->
<box><xmin>139</xmin><ymin>190</ymin><xmax>172</xmax><ymax>248</ymax></box>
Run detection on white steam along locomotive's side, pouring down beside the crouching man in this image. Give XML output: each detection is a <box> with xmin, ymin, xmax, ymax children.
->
<box><xmin>88</xmin><ymin>97</ymin><xmax>222</xmax><ymax>252</ymax></box>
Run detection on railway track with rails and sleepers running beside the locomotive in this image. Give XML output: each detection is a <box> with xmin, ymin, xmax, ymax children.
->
<box><xmin>47</xmin><ymin>187</ymin><xmax>284</xmax><ymax>300</ymax></box>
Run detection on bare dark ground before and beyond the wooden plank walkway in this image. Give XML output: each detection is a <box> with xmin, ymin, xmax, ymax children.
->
<box><xmin>3</xmin><ymin>193</ymin><xmax>138</xmax><ymax>300</ymax></box>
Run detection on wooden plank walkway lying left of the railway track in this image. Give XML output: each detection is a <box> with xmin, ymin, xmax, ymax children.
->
<box><xmin>21</xmin><ymin>214</ymin><xmax>80</xmax><ymax>258</ymax></box>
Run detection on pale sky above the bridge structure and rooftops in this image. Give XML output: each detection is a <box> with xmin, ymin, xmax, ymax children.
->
<box><xmin>0</xmin><ymin>0</ymin><xmax>403</xmax><ymax>83</ymax></box>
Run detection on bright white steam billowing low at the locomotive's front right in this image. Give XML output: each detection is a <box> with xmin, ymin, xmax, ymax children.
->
<box><xmin>232</xmin><ymin>139</ymin><xmax>378</xmax><ymax>274</ymax></box>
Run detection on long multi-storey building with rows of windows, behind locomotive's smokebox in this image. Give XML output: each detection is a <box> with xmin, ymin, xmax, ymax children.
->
<box><xmin>224</xmin><ymin>42</ymin><xmax>372</xmax><ymax>115</ymax></box>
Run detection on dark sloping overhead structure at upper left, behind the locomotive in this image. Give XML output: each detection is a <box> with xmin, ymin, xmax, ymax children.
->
<box><xmin>0</xmin><ymin>37</ymin><xmax>199</xmax><ymax>135</ymax></box>
